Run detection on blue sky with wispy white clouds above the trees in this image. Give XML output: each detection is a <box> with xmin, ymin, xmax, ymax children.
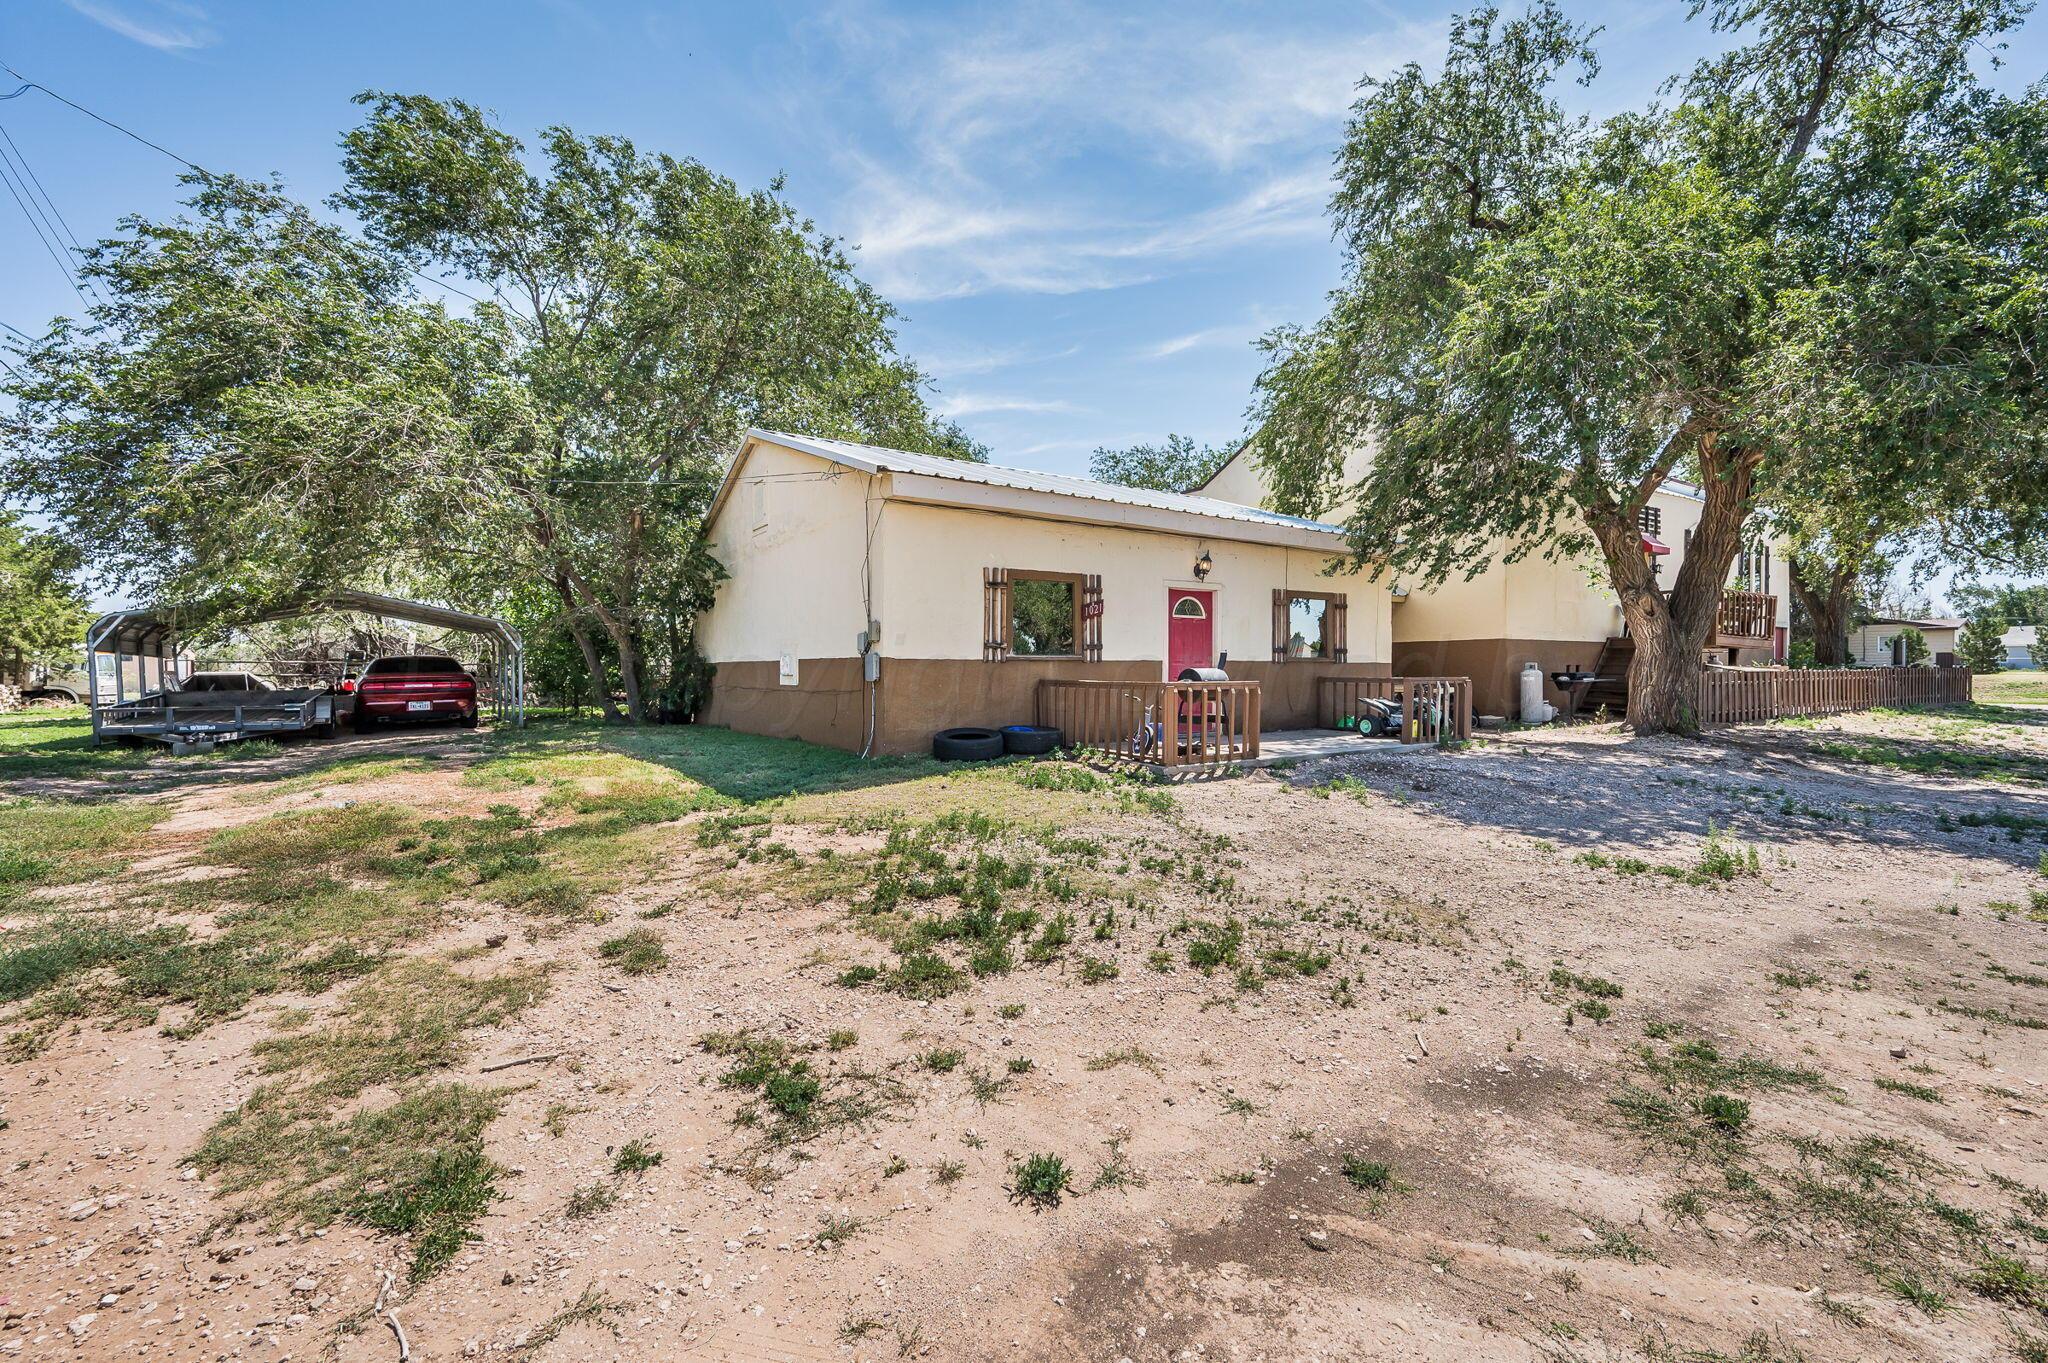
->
<box><xmin>0</xmin><ymin>0</ymin><xmax>2048</xmax><ymax>493</ymax></box>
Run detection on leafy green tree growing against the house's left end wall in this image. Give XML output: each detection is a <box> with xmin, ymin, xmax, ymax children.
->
<box><xmin>336</xmin><ymin>94</ymin><xmax>971</xmax><ymax>720</ymax></box>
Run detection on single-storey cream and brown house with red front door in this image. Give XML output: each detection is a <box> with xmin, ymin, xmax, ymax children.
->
<box><xmin>696</xmin><ymin>430</ymin><xmax>1393</xmax><ymax>753</ymax></box>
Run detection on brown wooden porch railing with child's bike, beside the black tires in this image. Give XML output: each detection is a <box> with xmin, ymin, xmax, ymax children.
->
<box><xmin>1036</xmin><ymin>677</ymin><xmax>1260</xmax><ymax>767</ymax></box>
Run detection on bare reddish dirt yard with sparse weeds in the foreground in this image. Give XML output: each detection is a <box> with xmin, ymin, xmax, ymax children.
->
<box><xmin>0</xmin><ymin>712</ymin><xmax>2048</xmax><ymax>1363</ymax></box>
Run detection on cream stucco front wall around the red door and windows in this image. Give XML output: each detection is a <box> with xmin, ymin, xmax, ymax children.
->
<box><xmin>879</xmin><ymin>501</ymin><xmax>1393</xmax><ymax>663</ymax></box>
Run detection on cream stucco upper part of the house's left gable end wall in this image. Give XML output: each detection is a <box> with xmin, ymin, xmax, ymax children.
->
<box><xmin>696</xmin><ymin>444</ymin><xmax>881</xmax><ymax>663</ymax></box>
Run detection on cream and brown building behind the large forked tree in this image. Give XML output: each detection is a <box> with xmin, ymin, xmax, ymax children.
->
<box><xmin>1196</xmin><ymin>440</ymin><xmax>1792</xmax><ymax>716</ymax></box>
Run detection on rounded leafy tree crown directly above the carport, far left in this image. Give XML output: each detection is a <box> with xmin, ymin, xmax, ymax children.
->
<box><xmin>0</xmin><ymin>176</ymin><xmax>491</xmax><ymax>626</ymax></box>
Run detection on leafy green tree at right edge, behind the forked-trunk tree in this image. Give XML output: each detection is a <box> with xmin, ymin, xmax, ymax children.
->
<box><xmin>1757</xmin><ymin>78</ymin><xmax>2048</xmax><ymax>665</ymax></box>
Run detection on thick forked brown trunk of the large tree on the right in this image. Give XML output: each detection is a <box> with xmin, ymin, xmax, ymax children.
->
<box><xmin>1587</xmin><ymin>432</ymin><xmax>1755</xmax><ymax>735</ymax></box>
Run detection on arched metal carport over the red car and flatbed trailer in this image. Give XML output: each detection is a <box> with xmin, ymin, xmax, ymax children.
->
<box><xmin>86</xmin><ymin>589</ymin><xmax>526</xmax><ymax>741</ymax></box>
